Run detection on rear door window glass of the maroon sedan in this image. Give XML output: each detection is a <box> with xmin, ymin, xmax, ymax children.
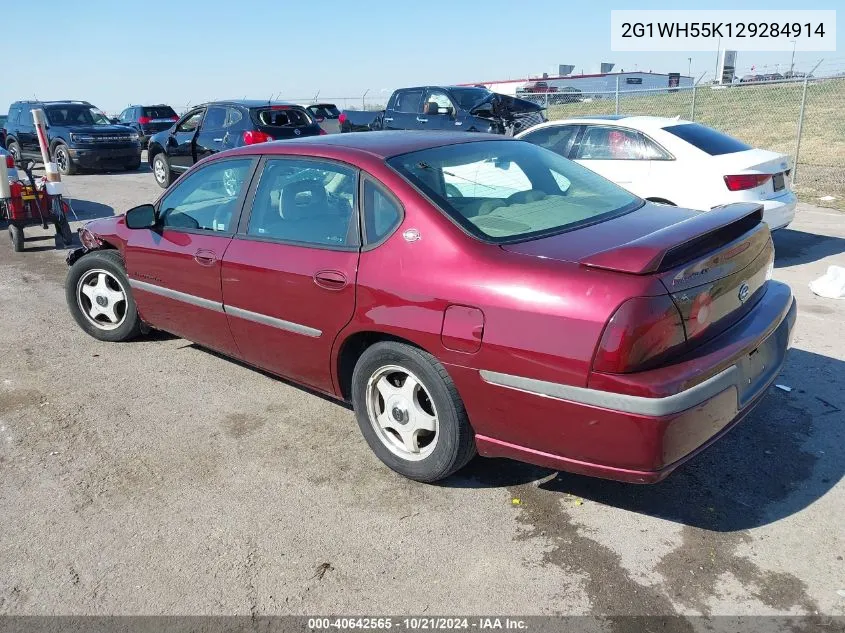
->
<box><xmin>247</xmin><ymin>158</ymin><xmax>360</xmax><ymax>248</ymax></box>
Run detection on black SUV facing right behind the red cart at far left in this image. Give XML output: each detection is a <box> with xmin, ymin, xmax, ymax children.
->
<box><xmin>6</xmin><ymin>101</ymin><xmax>141</xmax><ymax>174</ymax></box>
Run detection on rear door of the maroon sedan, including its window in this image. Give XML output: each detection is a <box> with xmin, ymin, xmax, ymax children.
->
<box><xmin>223</xmin><ymin>158</ymin><xmax>360</xmax><ymax>392</ymax></box>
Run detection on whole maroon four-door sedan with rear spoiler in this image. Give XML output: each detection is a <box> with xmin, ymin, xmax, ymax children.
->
<box><xmin>66</xmin><ymin>132</ymin><xmax>796</xmax><ymax>483</ymax></box>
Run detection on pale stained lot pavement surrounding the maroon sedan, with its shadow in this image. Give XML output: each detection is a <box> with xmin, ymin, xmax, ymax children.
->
<box><xmin>0</xmin><ymin>157</ymin><xmax>845</xmax><ymax>615</ymax></box>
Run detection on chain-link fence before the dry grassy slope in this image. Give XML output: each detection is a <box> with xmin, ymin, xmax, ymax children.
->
<box><xmin>519</xmin><ymin>77</ymin><xmax>845</xmax><ymax>210</ymax></box>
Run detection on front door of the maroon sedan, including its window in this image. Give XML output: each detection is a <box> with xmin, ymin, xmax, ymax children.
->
<box><xmin>125</xmin><ymin>157</ymin><xmax>255</xmax><ymax>356</ymax></box>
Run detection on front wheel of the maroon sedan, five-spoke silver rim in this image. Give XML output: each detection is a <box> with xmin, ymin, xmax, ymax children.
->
<box><xmin>65</xmin><ymin>250</ymin><xmax>141</xmax><ymax>343</ymax></box>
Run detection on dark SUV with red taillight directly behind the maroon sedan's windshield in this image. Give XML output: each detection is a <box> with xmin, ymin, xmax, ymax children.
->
<box><xmin>147</xmin><ymin>100</ymin><xmax>325</xmax><ymax>189</ymax></box>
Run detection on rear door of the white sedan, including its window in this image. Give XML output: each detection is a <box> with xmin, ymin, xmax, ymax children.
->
<box><xmin>573</xmin><ymin>125</ymin><xmax>650</xmax><ymax>195</ymax></box>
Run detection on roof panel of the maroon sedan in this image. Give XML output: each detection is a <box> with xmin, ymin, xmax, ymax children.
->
<box><xmin>231</xmin><ymin>130</ymin><xmax>510</xmax><ymax>159</ymax></box>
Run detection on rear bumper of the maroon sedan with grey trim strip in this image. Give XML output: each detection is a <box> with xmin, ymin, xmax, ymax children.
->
<box><xmin>449</xmin><ymin>282</ymin><xmax>797</xmax><ymax>483</ymax></box>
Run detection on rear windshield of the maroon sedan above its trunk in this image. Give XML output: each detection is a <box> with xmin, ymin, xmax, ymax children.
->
<box><xmin>388</xmin><ymin>140</ymin><xmax>643</xmax><ymax>242</ymax></box>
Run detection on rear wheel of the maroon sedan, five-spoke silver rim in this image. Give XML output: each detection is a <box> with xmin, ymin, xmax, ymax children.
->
<box><xmin>352</xmin><ymin>341</ymin><xmax>475</xmax><ymax>482</ymax></box>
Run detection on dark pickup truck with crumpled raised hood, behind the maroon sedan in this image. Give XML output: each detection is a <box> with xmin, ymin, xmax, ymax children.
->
<box><xmin>340</xmin><ymin>86</ymin><xmax>545</xmax><ymax>135</ymax></box>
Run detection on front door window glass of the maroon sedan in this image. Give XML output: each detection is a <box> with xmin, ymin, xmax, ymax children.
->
<box><xmin>159</xmin><ymin>158</ymin><xmax>252</xmax><ymax>233</ymax></box>
